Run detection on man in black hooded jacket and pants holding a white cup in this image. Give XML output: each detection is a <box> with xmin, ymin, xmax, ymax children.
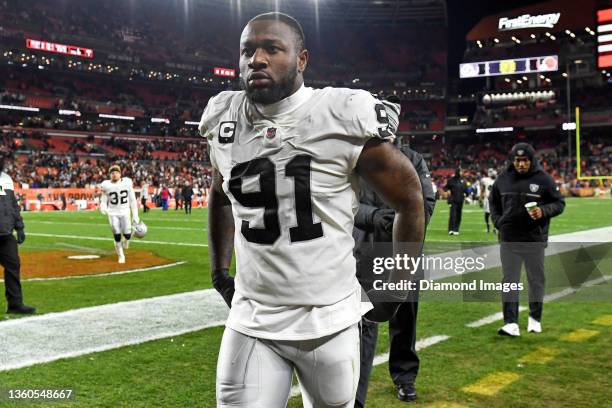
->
<box><xmin>489</xmin><ymin>143</ymin><xmax>565</xmax><ymax>337</ymax></box>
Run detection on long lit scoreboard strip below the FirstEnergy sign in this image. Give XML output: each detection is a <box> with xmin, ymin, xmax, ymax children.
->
<box><xmin>459</xmin><ymin>55</ymin><xmax>559</xmax><ymax>78</ymax></box>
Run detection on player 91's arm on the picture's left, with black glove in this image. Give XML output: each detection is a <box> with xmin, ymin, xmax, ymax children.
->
<box><xmin>208</xmin><ymin>169</ymin><xmax>234</xmax><ymax>306</ymax></box>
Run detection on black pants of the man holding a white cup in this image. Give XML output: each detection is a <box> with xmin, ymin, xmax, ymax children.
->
<box><xmin>500</xmin><ymin>242</ymin><xmax>545</xmax><ymax>323</ymax></box>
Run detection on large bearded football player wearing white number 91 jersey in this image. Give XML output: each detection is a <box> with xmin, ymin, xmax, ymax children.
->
<box><xmin>199</xmin><ymin>13</ymin><xmax>425</xmax><ymax>408</ymax></box>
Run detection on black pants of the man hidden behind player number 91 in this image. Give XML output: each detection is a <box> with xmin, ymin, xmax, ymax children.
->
<box><xmin>355</xmin><ymin>302</ymin><xmax>420</xmax><ymax>408</ymax></box>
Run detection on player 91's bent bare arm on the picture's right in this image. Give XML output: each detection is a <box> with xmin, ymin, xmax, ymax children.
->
<box><xmin>356</xmin><ymin>139</ymin><xmax>425</xmax><ymax>321</ymax></box>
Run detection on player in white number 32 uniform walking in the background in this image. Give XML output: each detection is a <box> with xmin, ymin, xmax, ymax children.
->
<box><xmin>100</xmin><ymin>165</ymin><xmax>140</xmax><ymax>263</ymax></box>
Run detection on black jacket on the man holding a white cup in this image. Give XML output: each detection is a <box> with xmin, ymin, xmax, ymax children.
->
<box><xmin>489</xmin><ymin>161</ymin><xmax>565</xmax><ymax>242</ymax></box>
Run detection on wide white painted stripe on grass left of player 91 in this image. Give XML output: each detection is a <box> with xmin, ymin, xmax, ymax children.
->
<box><xmin>0</xmin><ymin>289</ymin><xmax>229</xmax><ymax>371</ymax></box>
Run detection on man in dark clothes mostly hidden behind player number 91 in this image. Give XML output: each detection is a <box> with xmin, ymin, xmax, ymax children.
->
<box><xmin>353</xmin><ymin>139</ymin><xmax>436</xmax><ymax>408</ymax></box>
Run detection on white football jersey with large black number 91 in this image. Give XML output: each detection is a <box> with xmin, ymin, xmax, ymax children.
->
<box><xmin>200</xmin><ymin>87</ymin><xmax>393</xmax><ymax>338</ymax></box>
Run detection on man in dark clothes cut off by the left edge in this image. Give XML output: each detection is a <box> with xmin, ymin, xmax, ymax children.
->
<box><xmin>0</xmin><ymin>158</ymin><xmax>36</xmax><ymax>314</ymax></box>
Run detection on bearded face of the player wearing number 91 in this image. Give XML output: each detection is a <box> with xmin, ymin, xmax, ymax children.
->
<box><xmin>240</xmin><ymin>20</ymin><xmax>308</xmax><ymax>104</ymax></box>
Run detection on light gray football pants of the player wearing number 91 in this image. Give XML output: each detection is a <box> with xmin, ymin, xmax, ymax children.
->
<box><xmin>217</xmin><ymin>324</ymin><xmax>360</xmax><ymax>408</ymax></box>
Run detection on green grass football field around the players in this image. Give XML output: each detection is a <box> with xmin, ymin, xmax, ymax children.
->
<box><xmin>0</xmin><ymin>199</ymin><xmax>612</xmax><ymax>407</ymax></box>
